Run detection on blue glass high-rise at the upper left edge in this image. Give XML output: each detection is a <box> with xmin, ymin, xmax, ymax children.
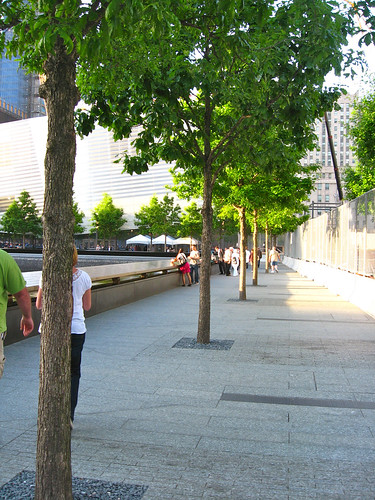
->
<box><xmin>0</xmin><ymin>34</ymin><xmax>46</xmax><ymax>123</ymax></box>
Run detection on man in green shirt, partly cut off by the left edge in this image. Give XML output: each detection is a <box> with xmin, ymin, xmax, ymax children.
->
<box><xmin>0</xmin><ymin>250</ymin><xmax>34</xmax><ymax>378</ymax></box>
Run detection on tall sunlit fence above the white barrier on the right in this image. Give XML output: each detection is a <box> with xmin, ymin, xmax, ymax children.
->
<box><xmin>284</xmin><ymin>189</ymin><xmax>375</xmax><ymax>276</ymax></box>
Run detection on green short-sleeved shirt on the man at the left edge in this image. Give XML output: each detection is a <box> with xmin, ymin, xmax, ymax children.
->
<box><xmin>0</xmin><ymin>250</ymin><xmax>26</xmax><ymax>332</ymax></box>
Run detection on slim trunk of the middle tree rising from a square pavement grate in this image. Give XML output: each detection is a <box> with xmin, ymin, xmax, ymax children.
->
<box><xmin>197</xmin><ymin>164</ymin><xmax>212</xmax><ymax>344</ymax></box>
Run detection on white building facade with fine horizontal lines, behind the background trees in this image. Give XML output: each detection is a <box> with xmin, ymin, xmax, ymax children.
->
<box><xmin>0</xmin><ymin>117</ymin><xmax>178</xmax><ymax>229</ymax></box>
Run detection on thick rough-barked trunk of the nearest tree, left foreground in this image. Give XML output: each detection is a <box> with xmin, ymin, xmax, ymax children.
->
<box><xmin>35</xmin><ymin>40</ymin><xmax>78</xmax><ymax>500</ymax></box>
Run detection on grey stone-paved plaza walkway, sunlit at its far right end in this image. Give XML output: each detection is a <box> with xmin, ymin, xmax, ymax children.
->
<box><xmin>0</xmin><ymin>265</ymin><xmax>375</xmax><ymax>500</ymax></box>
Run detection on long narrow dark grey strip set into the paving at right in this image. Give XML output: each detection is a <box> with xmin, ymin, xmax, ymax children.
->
<box><xmin>220</xmin><ymin>392</ymin><xmax>375</xmax><ymax>410</ymax></box>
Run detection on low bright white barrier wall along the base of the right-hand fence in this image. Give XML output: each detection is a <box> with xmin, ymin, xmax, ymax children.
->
<box><xmin>283</xmin><ymin>257</ymin><xmax>375</xmax><ymax>317</ymax></box>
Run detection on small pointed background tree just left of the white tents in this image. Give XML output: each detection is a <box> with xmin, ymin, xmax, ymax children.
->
<box><xmin>90</xmin><ymin>193</ymin><xmax>126</xmax><ymax>247</ymax></box>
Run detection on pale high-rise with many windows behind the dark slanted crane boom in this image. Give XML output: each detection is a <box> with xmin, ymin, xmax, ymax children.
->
<box><xmin>302</xmin><ymin>94</ymin><xmax>356</xmax><ymax>216</ymax></box>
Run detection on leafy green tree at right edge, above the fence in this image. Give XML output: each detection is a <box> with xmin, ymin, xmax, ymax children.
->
<box><xmin>344</xmin><ymin>91</ymin><xmax>375</xmax><ymax>200</ymax></box>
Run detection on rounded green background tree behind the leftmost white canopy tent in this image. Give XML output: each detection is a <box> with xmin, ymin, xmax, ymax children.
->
<box><xmin>134</xmin><ymin>194</ymin><xmax>181</xmax><ymax>246</ymax></box>
